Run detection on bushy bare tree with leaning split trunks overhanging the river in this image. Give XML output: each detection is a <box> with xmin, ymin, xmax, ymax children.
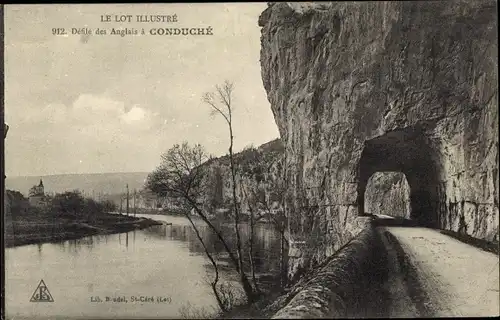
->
<box><xmin>146</xmin><ymin>142</ymin><xmax>253</xmax><ymax>308</ymax></box>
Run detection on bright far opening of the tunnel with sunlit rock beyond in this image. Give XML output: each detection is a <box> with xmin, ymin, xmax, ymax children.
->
<box><xmin>364</xmin><ymin>171</ymin><xmax>411</xmax><ymax>219</ymax></box>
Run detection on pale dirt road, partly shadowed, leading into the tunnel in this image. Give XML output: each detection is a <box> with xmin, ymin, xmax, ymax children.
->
<box><xmin>378</xmin><ymin>217</ymin><xmax>500</xmax><ymax>317</ymax></box>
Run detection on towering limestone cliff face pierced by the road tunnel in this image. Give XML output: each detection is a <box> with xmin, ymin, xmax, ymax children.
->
<box><xmin>259</xmin><ymin>0</ymin><xmax>499</xmax><ymax>278</ymax></box>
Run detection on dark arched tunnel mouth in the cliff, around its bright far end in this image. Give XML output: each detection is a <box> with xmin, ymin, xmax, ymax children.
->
<box><xmin>358</xmin><ymin>127</ymin><xmax>439</xmax><ymax>228</ymax></box>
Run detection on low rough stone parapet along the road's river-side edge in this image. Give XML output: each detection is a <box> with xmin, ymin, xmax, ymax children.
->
<box><xmin>268</xmin><ymin>221</ymin><xmax>387</xmax><ymax>319</ymax></box>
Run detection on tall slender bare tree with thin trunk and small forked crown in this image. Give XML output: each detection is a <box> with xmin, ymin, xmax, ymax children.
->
<box><xmin>203</xmin><ymin>81</ymin><xmax>255</xmax><ymax>302</ymax></box>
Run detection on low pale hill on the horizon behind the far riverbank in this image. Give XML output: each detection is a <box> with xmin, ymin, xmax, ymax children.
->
<box><xmin>5</xmin><ymin>172</ymin><xmax>148</xmax><ymax>196</ymax></box>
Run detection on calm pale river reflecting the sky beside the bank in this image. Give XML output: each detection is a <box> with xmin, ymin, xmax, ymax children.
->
<box><xmin>5</xmin><ymin>214</ymin><xmax>279</xmax><ymax>319</ymax></box>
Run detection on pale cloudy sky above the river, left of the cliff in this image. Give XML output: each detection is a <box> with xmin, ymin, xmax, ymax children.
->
<box><xmin>4</xmin><ymin>3</ymin><xmax>279</xmax><ymax>176</ymax></box>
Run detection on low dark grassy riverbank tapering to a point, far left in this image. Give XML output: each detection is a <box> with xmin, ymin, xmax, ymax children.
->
<box><xmin>4</xmin><ymin>213</ymin><xmax>162</xmax><ymax>248</ymax></box>
